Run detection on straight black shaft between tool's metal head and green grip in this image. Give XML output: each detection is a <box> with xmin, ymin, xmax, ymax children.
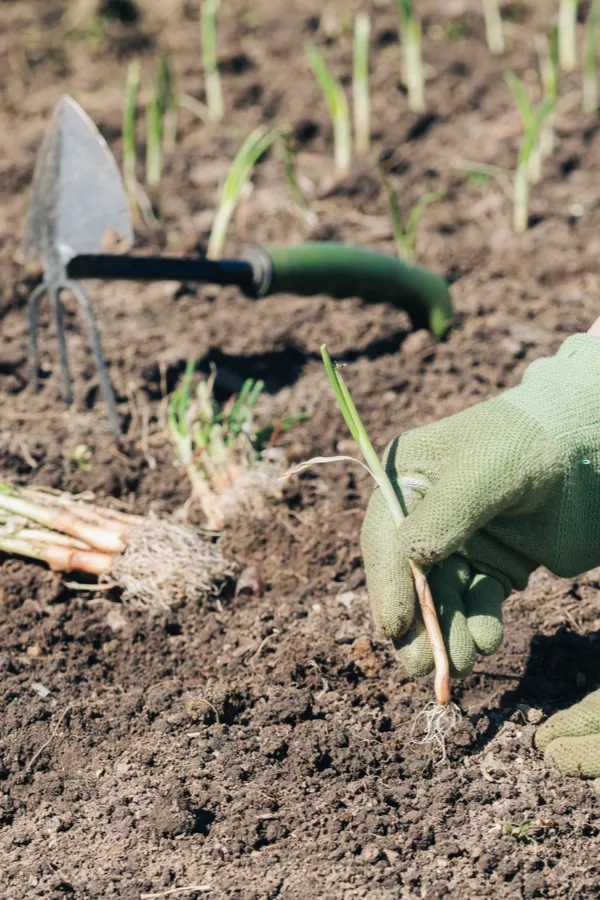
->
<box><xmin>67</xmin><ymin>253</ymin><xmax>254</xmax><ymax>294</ymax></box>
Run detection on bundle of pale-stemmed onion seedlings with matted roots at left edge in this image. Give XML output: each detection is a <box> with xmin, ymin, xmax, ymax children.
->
<box><xmin>0</xmin><ymin>483</ymin><xmax>232</xmax><ymax>609</ymax></box>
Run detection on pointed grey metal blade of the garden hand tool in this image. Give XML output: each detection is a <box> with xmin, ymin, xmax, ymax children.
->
<box><xmin>24</xmin><ymin>95</ymin><xmax>133</xmax><ymax>280</ymax></box>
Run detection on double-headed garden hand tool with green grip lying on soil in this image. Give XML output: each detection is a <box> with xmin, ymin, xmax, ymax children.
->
<box><xmin>24</xmin><ymin>95</ymin><xmax>452</xmax><ymax>430</ymax></box>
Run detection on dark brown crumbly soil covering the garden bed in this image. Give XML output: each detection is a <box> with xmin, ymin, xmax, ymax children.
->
<box><xmin>0</xmin><ymin>0</ymin><xmax>600</xmax><ymax>900</ymax></box>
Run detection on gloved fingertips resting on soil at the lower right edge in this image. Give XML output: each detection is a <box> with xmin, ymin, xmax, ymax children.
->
<box><xmin>534</xmin><ymin>691</ymin><xmax>600</xmax><ymax>793</ymax></box>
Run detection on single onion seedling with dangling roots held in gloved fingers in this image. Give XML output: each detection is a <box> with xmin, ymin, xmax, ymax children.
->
<box><xmin>283</xmin><ymin>344</ymin><xmax>462</xmax><ymax>758</ymax></box>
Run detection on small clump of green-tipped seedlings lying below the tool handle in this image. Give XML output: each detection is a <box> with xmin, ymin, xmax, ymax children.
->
<box><xmin>167</xmin><ymin>360</ymin><xmax>306</xmax><ymax>531</ymax></box>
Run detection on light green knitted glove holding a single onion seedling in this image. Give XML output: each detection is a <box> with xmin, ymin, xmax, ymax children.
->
<box><xmin>361</xmin><ymin>334</ymin><xmax>600</xmax><ymax>677</ymax></box>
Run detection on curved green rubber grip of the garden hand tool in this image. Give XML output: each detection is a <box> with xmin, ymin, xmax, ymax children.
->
<box><xmin>265</xmin><ymin>241</ymin><xmax>452</xmax><ymax>338</ymax></box>
